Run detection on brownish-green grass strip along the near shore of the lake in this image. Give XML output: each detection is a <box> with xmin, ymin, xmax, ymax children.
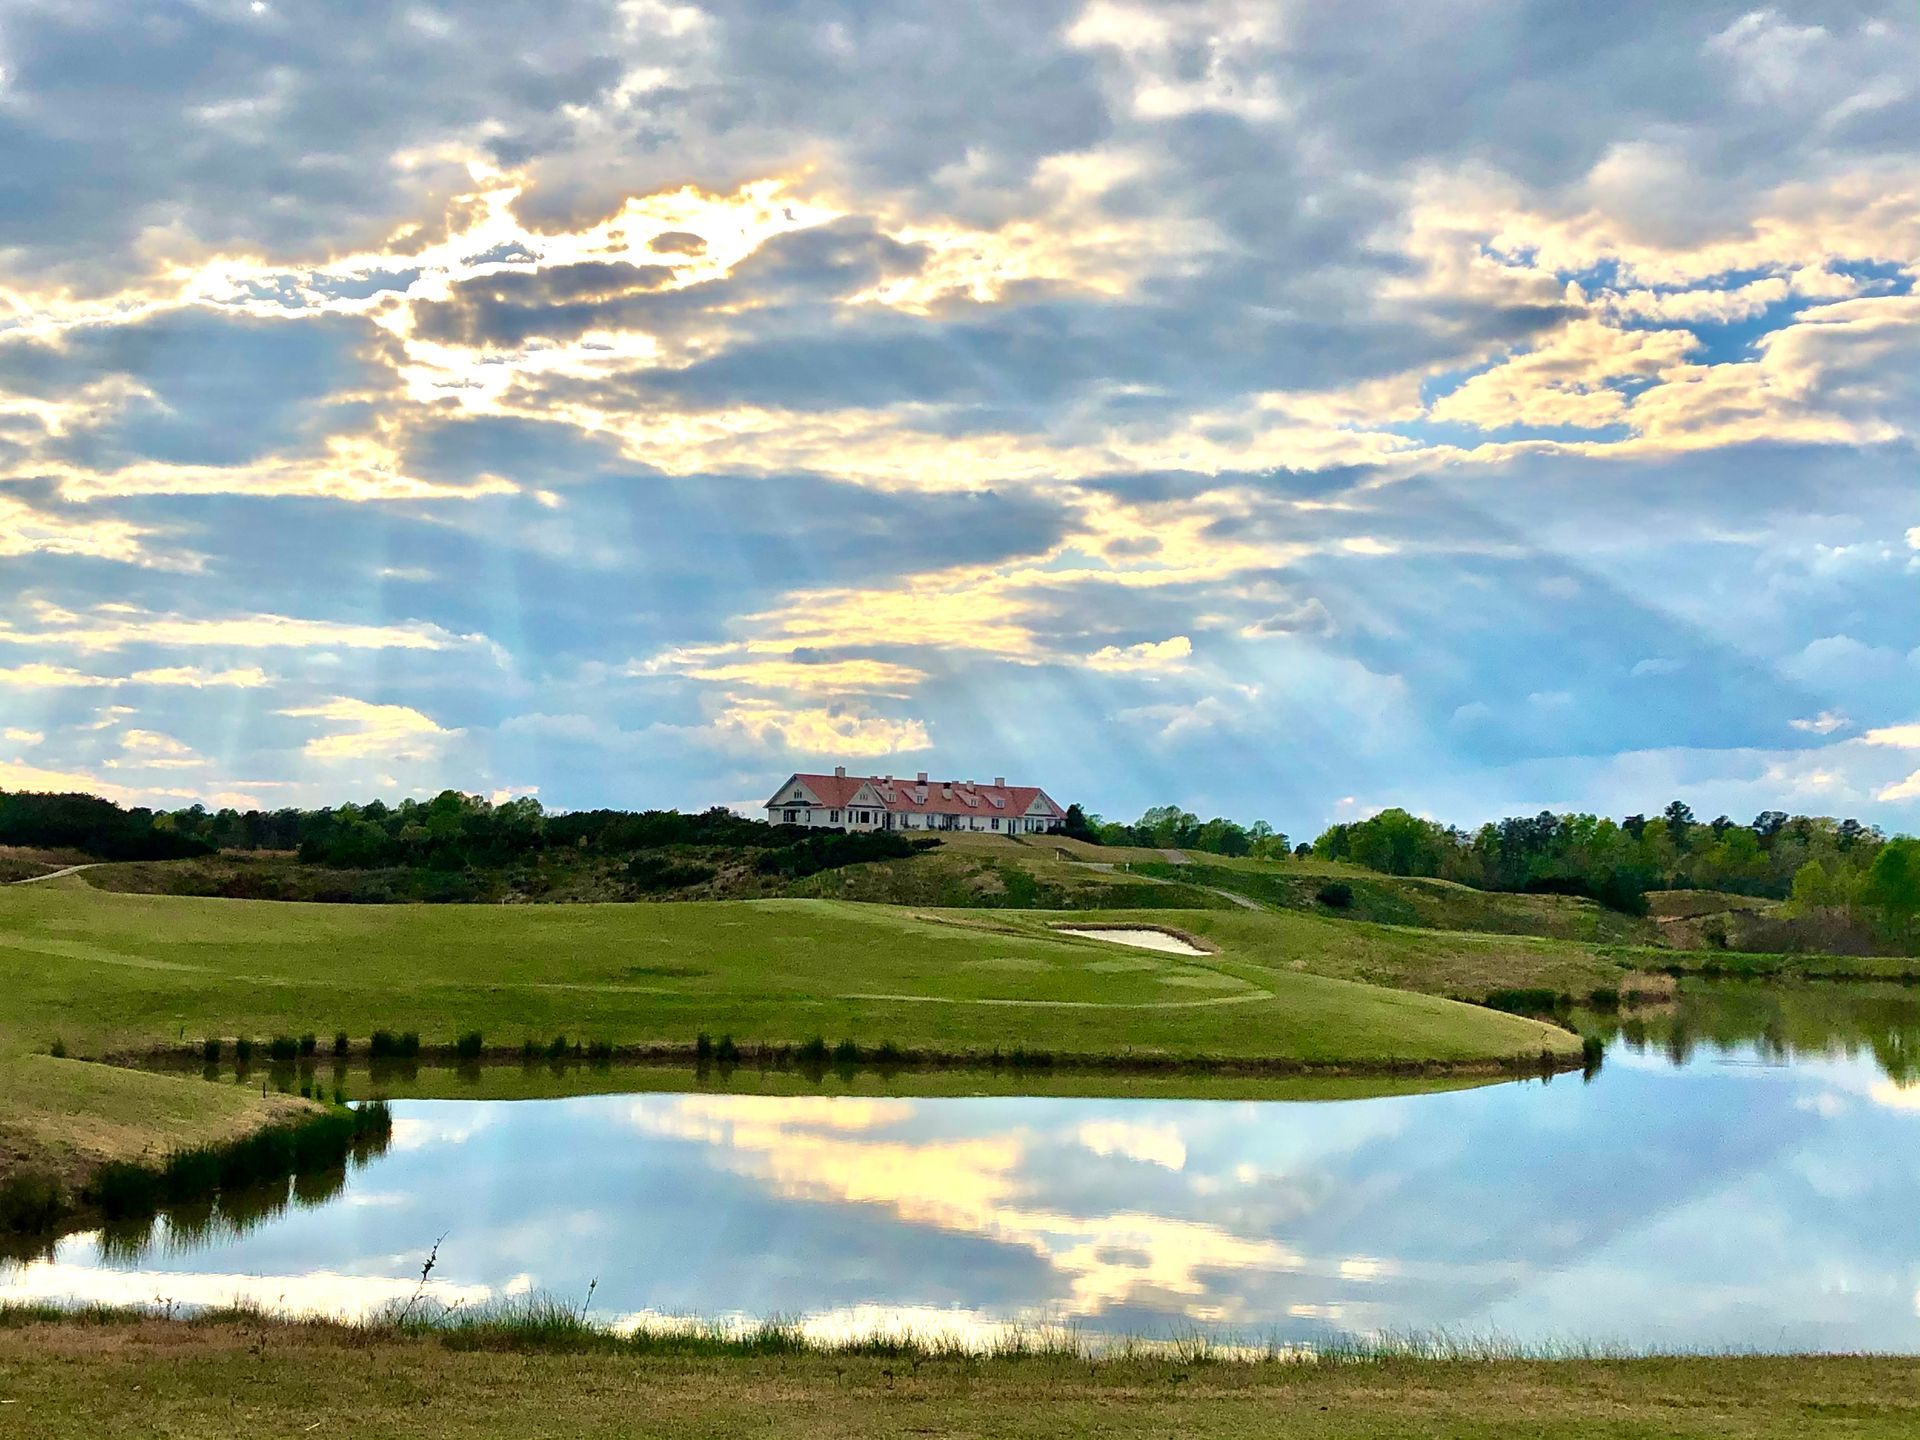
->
<box><xmin>0</xmin><ymin>1321</ymin><xmax>1920</xmax><ymax>1440</ymax></box>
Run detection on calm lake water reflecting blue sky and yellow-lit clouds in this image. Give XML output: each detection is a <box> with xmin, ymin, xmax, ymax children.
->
<box><xmin>0</xmin><ymin>987</ymin><xmax>1920</xmax><ymax>1352</ymax></box>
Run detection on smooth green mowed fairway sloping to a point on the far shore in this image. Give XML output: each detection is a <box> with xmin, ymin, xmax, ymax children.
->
<box><xmin>0</xmin><ymin>879</ymin><xmax>1578</xmax><ymax>1068</ymax></box>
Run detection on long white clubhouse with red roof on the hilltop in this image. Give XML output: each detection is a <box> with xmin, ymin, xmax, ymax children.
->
<box><xmin>766</xmin><ymin>766</ymin><xmax>1068</xmax><ymax>835</ymax></box>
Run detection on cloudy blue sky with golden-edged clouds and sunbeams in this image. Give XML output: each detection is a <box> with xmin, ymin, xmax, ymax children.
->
<box><xmin>0</xmin><ymin>0</ymin><xmax>1920</xmax><ymax>837</ymax></box>
